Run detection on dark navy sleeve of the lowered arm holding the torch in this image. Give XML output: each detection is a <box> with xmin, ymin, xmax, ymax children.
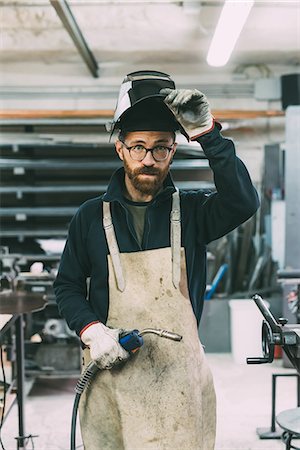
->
<box><xmin>53</xmin><ymin>204</ymin><xmax>98</xmax><ymax>335</ymax></box>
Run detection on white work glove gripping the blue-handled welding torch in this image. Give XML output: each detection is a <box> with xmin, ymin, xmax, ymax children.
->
<box><xmin>80</xmin><ymin>322</ymin><xmax>129</xmax><ymax>369</ymax></box>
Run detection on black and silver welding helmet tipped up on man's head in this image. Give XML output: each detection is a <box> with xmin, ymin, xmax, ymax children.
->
<box><xmin>107</xmin><ymin>70</ymin><xmax>180</xmax><ymax>135</ymax></box>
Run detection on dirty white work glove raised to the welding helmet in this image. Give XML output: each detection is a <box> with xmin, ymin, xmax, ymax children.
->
<box><xmin>160</xmin><ymin>88</ymin><xmax>214</xmax><ymax>140</ymax></box>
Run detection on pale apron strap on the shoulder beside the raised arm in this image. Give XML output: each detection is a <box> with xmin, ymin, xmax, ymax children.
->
<box><xmin>171</xmin><ymin>188</ymin><xmax>181</xmax><ymax>289</ymax></box>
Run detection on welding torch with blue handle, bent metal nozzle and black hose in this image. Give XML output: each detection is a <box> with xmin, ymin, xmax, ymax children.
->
<box><xmin>71</xmin><ymin>328</ymin><xmax>182</xmax><ymax>450</ymax></box>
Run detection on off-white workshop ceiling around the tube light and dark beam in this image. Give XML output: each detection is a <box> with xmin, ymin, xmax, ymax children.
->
<box><xmin>0</xmin><ymin>0</ymin><xmax>300</xmax><ymax>84</ymax></box>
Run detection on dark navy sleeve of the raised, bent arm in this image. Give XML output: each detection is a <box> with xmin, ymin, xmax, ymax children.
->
<box><xmin>197</xmin><ymin>126</ymin><xmax>259</xmax><ymax>244</ymax></box>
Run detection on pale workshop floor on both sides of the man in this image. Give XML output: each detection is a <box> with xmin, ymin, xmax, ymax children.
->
<box><xmin>2</xmin><ymin>354</ymin><xmax>297</xmax><ymax>450</ymax></box>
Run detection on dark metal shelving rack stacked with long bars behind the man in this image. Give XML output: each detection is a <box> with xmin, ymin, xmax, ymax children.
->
<box><xmin>0</xmin><ymin>119</ymin><xmax>214</xmax><ymax>246</ymax></box>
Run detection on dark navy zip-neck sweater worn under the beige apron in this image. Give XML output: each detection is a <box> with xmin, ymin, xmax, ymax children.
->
<box><xmin>54</xmin><ymin>127</ymin><xmax>259</xmax><ymax>334</ymax></box>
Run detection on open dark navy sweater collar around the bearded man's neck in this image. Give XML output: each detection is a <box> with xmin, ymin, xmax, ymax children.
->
<box><xmin>102</xmin><ymin>167</ymin><xmax>175</xmax><ymax>205</ymax></box>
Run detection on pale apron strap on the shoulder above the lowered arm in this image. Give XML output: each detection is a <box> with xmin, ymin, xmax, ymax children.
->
<box><xmin>103</xmin><ymin>202</ymin><xmax>125</xmax><ymax>292</ymax></box>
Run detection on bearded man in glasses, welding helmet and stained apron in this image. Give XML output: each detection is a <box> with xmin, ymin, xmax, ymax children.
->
<box><xmin>55</xmin><ymin>71</ymin><xmax>259</xmax><ymax>450</ymax></box>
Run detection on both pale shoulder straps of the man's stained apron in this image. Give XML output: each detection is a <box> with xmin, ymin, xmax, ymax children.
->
<box><xmin>103</xmin><ymin>188</ymin><xmax>181</xmax><ymax>292</ymax></box>
